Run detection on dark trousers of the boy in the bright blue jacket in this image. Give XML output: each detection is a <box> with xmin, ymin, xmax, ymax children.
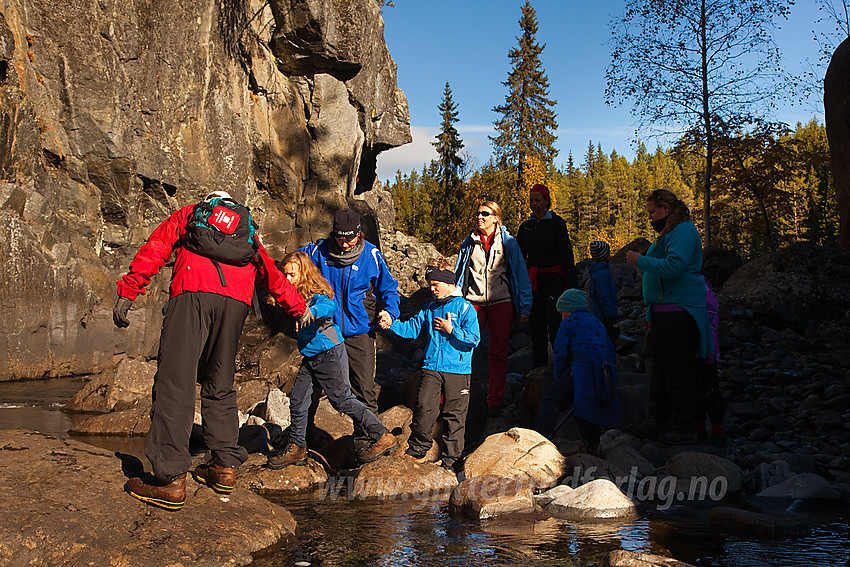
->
<box><xmin>408</xmin><ymin>369</ymin><xmax>470</xmax><ymax>466</ymax></box>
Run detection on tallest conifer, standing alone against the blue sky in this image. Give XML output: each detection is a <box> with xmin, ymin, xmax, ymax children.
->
<box><xmin>490</xmin><ymin>0</ymin><xmax>558</xmax><ymax>222</ymax></box>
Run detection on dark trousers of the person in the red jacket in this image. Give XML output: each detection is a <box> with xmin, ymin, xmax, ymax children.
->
<box><xmin>145</xmin><ymin>292</ymin><xmax>248</xmax><ymax>482</ymax></box>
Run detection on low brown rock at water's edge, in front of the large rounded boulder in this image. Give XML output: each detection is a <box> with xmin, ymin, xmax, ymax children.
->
<box><xmin>449</xmin><ymin>475</ymin><xmax>535</xmax><ymax>520</ymax></box>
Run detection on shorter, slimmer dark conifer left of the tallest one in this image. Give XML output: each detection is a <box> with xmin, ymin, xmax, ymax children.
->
<box><xmin>431</xmin><ymin>82</ymin><xmax>465</xmax><ymax>252</ymax></box>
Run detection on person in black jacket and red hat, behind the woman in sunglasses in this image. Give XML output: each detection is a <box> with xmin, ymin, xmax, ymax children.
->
<box><xmin>516</xmin><ymin>184</ymin><xmax>578</xmax><ymax>368</ymax></box>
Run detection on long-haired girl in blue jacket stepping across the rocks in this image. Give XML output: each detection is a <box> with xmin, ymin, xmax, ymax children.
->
<box><xmin>268</xmin><ymin>251</ymin><xmax>398</xmax><ymax>469</ymax></box>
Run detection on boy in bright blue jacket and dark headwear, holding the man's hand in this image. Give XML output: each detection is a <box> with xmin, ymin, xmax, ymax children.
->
<box><xmin>380</xmin><ymin>258</ymin><xmax>481</xmax><ymax>470</ymax></box>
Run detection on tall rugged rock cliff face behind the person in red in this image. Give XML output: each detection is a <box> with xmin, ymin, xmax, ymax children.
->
<box><xmin>0</xmin><ymin>0</ymin><xmax>410</xmax><ymax>380</ymax></box>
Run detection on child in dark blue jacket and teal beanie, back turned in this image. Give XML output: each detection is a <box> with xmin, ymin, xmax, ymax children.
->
<box><xmin>535</xmin><ymin>289</ymin><xmax>620</xmax><ymax>452</ymax></box>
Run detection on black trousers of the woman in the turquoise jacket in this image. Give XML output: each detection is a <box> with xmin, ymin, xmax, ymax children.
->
<box><xmin>649</xmin><ymin>311</ymin><xmax>701</xmax><ymax>433</ymax></box>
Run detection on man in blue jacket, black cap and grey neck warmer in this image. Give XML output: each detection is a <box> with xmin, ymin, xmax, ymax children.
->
<box><xmin>301</xmin><ymin>209</ymin><xmax>399</xmax><ymax>454</ymax></box>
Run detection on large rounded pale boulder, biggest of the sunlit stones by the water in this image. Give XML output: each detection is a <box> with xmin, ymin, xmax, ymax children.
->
<box><xmin>464</xmin><ymin>427</ymin><xmax>564</xmax><ymax>488</ymax></box>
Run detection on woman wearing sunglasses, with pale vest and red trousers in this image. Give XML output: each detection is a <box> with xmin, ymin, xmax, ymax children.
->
<box><xmin>455</xmin><ymin>201</ymin><xmax>531</xmax><ymax>416</ymax></box>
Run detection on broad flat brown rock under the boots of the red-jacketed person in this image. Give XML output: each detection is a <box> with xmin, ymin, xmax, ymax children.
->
<box><xmin>0</xmin><ymin>430</ymin><xmax>295</xmax><ymax>567</ymax></box>
